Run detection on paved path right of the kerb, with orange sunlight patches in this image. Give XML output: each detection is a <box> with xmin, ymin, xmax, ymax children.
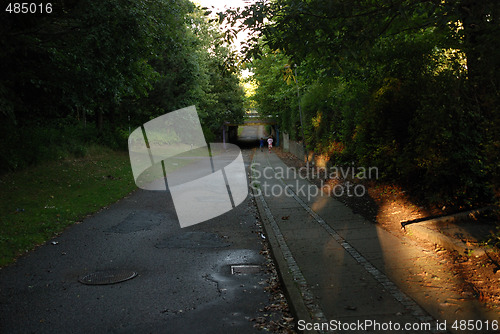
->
<box><xmin>251</xmin><ymin>152</ymin><xmax>499</xmax><ymax>333</ymax></box>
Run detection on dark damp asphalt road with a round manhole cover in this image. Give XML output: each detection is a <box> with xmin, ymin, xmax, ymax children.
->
<box><xmin>0</xmin><ymin>150</ymin><xmax>280</xmax><ymax>333</ymax></box>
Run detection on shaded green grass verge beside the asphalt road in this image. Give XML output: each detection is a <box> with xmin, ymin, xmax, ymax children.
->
<box><xmin>0</xmin><ymin>146</ymin><xmax>136</xmax><ymax>266</ymax></box>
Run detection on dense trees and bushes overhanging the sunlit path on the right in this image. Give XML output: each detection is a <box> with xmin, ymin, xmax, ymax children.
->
<box><xmin>229</xmin><ymin>0</ymin><xmax>500</xmax><ymax>206</ymax></box>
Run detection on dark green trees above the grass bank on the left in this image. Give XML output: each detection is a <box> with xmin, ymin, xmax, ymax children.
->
<box><xmin>0</xmin><ymin>0</ymin><xmax>243</xmax><ymax>172</ymax></box>
